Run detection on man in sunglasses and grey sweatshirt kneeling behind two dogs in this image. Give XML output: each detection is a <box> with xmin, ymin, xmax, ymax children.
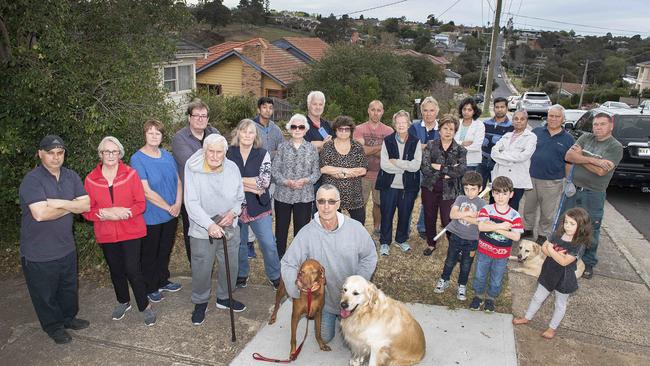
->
<box><xmin>281</xmin><ymin>184</ymin><xmax>377</xmax><ymax>343</ymax></box>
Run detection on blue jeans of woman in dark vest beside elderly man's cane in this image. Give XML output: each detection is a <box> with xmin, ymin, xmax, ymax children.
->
<box><xmin>237</xmin><ymin>215</ymin><xmax>280</xmax><ymax>280</ymax></box>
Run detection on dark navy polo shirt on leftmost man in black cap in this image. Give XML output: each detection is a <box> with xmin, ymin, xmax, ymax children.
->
<box><xmin>18</xmin><ymin>165</ymin><xmax>87</xmax><ymax>262</ymax></box>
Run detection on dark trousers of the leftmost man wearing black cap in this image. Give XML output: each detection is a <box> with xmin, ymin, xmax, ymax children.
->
<box><xmin>21</xmin><ymin>251</ymin><xmax>79</xmax><ymax>334</ymax></box>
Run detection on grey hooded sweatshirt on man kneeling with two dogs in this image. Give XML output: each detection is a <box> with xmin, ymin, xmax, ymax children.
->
<box><xmin>281</xmin><ymin>212</ymin><xmax>377</xmax><ymax>314</ymax></box>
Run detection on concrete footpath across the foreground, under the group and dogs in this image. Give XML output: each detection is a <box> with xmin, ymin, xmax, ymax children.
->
<box><xmin>0</xmin><ymin>205</ymin><xmax>650</xmax><ymax>366</ymax></box>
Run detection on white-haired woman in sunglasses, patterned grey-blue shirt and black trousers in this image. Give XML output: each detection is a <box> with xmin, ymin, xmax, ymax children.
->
<box><xmin>271</xmin><ymin>114</ymin><xmax>320</xmax><ymax>258</ymax></box>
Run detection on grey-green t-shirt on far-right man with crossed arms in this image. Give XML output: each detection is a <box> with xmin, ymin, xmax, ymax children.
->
<box><xmin>573</xmin><ymin>133</ymin><xmax>623</xmax><ymax>192</ymax></box>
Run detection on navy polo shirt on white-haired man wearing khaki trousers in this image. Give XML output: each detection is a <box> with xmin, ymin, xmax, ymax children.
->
<box><xmin>530</xmin><ymin>126</ymin><xmax>573</xmax><ymax>180</ymax></box>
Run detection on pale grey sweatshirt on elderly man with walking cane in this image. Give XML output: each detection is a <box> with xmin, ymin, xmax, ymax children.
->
<box><xmin>184</xmin><ymin>149</ymin><xmax>244</xmax><ymax>239</ymax></box>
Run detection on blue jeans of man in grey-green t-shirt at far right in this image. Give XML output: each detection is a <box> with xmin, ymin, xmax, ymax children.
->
<box><xmin>562</xmin><ymin>189</ymin><xmax>607</xmax><ymax>267</ymax></box>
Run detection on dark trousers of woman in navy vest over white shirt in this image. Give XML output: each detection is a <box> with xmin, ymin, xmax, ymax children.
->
<box><xmin>379</xmin><ymin>188</ymin><xmax>418</xmax><ymax>245</ymax></box>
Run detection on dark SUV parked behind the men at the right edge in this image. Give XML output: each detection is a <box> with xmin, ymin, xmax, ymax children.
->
<box><xmin>565</xmin><ymin>108</ymin><xmax>650</xmax><ymax>187</ymax></box>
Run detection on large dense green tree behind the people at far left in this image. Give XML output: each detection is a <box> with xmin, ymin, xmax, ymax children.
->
<box><xmin>0</xmin><ymin>0</ymin><xmax>191</xmax><ymax>254</ymax></box>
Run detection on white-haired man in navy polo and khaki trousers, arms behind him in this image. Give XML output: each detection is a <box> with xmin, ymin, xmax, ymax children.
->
<box><xmin>522</xmin><ymin>104</ymin><xmax>573</xmax><ymax>244</ymax></box>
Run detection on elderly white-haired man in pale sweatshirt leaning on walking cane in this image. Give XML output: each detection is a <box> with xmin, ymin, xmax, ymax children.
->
<box><xmin>184</xmin><ymin>134</ymin><xmax>246</xmax><ymax>325</ymax></box>
